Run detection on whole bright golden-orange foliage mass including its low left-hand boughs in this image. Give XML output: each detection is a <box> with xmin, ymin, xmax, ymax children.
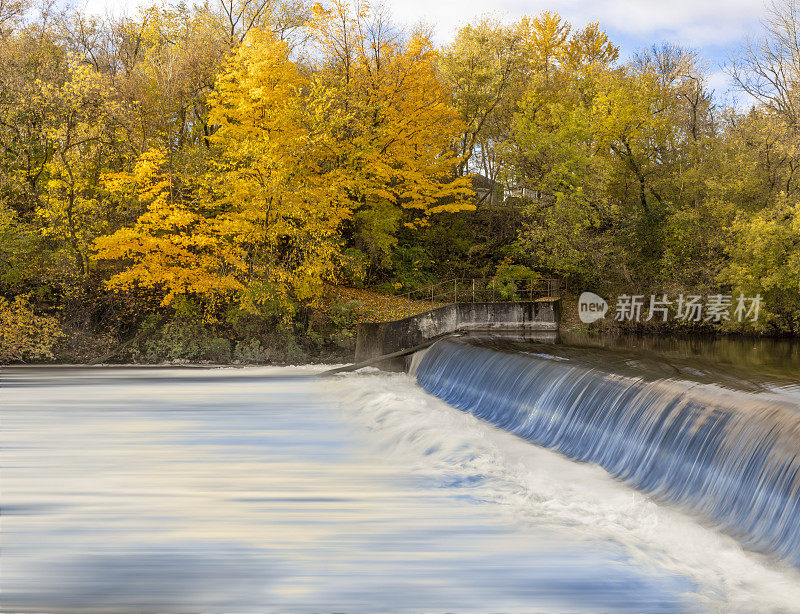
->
<box><xmin>93</xmin><ymin>5</ymin><xmax>471</xmax><ymax>322</ymax></box>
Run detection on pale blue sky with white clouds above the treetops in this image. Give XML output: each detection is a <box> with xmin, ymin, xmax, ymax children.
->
<box><xmin>86</xmin><ymin>0</ymin><xmax>765</xmax><ymax>98</ymax></box>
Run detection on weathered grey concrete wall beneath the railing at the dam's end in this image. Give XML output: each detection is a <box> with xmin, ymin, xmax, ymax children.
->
<box><xmin>355</xmin><ymin>299</ymin><xmax>560</xmax><ymax>362</ymax></box>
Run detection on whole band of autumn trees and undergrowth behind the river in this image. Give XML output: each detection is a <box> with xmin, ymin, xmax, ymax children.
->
<box><xmin>0</xmin><ymin>0</ymin><xmax>800</xmax><ymax>363</ymax></box>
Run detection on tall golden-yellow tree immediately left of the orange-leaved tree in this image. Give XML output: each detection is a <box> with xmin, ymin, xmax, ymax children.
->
<box><xmin>210</xmin><ymin>30</ymin><xmax>350</xmax><ymax>318</ymax></box>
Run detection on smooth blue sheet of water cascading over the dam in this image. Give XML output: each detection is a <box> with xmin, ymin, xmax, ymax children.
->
<box><xmin>414</xmin><ymin>341</ymin><xmax>800</xmax><ymax>566</ymax></box>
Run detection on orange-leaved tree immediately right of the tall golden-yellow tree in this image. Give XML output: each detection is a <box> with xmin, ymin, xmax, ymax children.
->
<box><xmin>310</xmin><ymin>0</ymin><xmax>473</xmax><ymax>268</ymax></box>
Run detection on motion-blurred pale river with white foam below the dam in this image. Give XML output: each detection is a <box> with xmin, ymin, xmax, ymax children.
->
<box><xmin>0</xmin><ymin>347</ymin><xmax>800</xmax><ymax>612</ymax></box>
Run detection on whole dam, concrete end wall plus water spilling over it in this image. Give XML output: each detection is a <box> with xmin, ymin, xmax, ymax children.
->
<box><xmin>346</xmin><ymin>297</ymin><xmax>800</xmax><ymax>567</ymax></box>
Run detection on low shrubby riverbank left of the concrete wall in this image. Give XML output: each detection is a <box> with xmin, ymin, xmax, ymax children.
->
<box><xmin>0</xmin><ymin>286</ymin><xmax>440</xmax><ymax>366</ymax></box>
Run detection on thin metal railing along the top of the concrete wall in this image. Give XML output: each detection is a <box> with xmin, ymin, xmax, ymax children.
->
<box><xmin>387</xmin><ymin>278</ymin><xmax>561</xmax><ymax>305</ymax></box>
